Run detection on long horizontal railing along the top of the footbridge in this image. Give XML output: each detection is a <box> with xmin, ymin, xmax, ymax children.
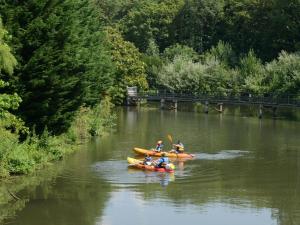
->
<box><xmin>138</xmin><ymin>90</ymin><xmax>300</xmax><ymax>107</ymax></box>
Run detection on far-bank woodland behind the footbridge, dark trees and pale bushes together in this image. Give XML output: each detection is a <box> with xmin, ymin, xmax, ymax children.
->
<box><xmin>102</xmin><ymin>0</ymin><xmax>300</xmax><ymax>96</ymax></box>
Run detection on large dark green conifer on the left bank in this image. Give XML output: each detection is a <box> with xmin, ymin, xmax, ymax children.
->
<box><xmin>0</xmin><ymin>0</ymin><xmax>114</xmax><ymax>133</ymax></box>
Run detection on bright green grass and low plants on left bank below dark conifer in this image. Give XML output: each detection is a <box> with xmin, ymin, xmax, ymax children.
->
<box><xmin>0</xmin><ymin>97</ymin><xmax>116</xmax><ymax>177</ymax></box>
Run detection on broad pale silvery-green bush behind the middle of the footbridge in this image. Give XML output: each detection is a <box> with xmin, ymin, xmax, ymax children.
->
<box><xmin>159</xmin><ymin>56</ymin><xmax>236</xmax><ymax>95</ymax></box>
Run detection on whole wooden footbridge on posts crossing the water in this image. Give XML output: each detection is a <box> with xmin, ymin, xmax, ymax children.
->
<box><xmin>127</xmin><ymin>90</ymin><xmax>300</xmax><ymax>118</ymax></box>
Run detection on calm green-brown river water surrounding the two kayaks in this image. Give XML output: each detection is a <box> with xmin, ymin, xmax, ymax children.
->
<box><xmin>2</xmin><ymin>108</ymin><xmax>300</xmax><ymax>225</ymax></box>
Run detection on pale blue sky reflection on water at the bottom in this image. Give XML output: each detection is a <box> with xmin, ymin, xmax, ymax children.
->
<box><xmin>96</xmin><ymin>190</ymin><xmax>277</xmax><ymax>225</ymax></box>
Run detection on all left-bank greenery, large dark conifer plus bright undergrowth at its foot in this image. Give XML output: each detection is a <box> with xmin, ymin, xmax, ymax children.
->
<box><xmin>0</xmin><ymin>1</ymin><xmax>115</xmax><ymax>177</ymax></box>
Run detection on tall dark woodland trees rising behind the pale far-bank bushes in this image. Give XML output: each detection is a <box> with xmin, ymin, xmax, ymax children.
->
<box><xmin>111</xmin><ymin>0</ymin><xmax>300</xmax><ymax>61</ymax></box>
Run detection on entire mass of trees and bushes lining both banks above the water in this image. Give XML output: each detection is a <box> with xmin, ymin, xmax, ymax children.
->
<box><xmin>0</xmin><ymin>0</ymin><xmax>300</xmax><ymax>174</ymax></box>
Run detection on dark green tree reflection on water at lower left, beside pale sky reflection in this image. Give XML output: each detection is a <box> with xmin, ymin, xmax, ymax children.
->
<box><xmin>0</xmin><ymin>145</ymin><xmax>112</xmax><ymax>225</ymax></box>
